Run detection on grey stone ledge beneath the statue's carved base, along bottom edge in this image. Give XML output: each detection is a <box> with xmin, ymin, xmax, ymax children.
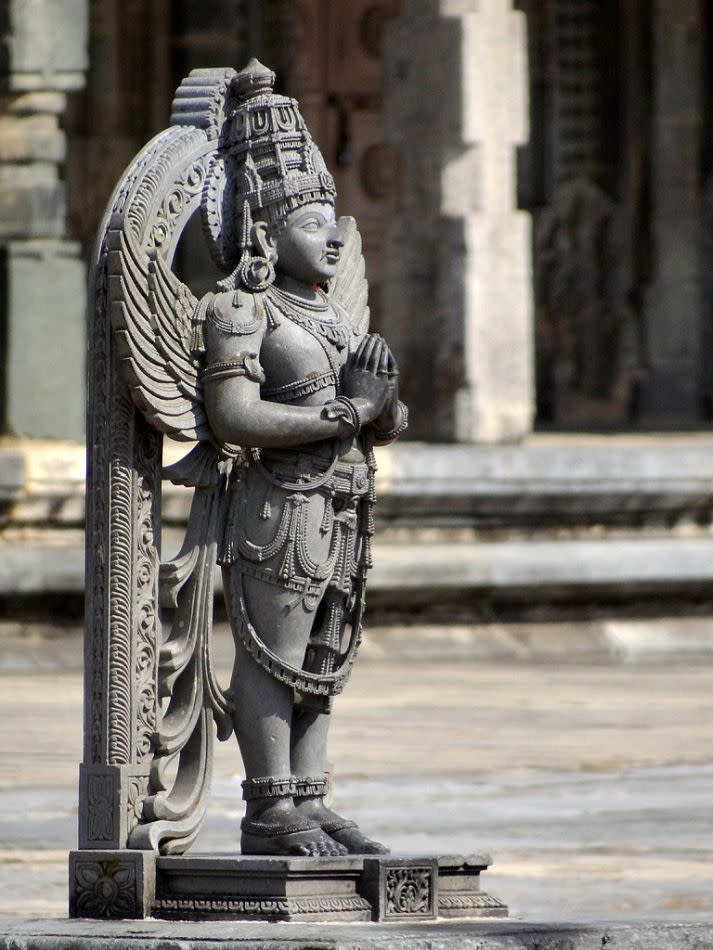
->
<box><xmin>0</xmin><ymin>920</ymin><xmax>713</xmax><ymax>950</ymax></box>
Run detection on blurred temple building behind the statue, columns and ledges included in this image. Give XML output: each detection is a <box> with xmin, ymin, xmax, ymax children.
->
<box><xmin>0</xmin><ymin>0</ymin><xmax>713</xmax><ymax>628</ymax></box>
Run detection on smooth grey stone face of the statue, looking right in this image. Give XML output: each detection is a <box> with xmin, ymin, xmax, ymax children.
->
<box><xmin>275</xmin><ymin>201</ymin><xmax>344</xmax><ymax>284</ymax></box>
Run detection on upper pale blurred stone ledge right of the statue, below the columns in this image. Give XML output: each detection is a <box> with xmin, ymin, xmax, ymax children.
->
<box><xmin>377</xmin><ymin>434</ymin><xmax>713</xmax><ymax>530</ymax></box>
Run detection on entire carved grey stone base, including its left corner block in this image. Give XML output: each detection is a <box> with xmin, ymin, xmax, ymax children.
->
<box><xmin>70</xmin><ymin>851</ymin><xmax>508</xmax><ymax>923</ymax></box>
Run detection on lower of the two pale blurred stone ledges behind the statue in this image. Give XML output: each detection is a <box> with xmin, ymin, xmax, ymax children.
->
<box><xmin>0</xmin><ymin>533</ymin><xmax>713</xmax><ymax>601</ymax></box>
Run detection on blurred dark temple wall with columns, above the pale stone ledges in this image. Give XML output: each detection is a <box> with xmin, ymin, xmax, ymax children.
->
<box><xmin>0</xmin><ymin>0</ymin><xmax>713</xmax><ymax>443</ymax></box>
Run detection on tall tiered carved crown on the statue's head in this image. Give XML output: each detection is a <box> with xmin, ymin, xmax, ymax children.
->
<box><xmin>197</xmin><ymin>59</ymin><xmax>336</xmax><ymax>284</ymax></box>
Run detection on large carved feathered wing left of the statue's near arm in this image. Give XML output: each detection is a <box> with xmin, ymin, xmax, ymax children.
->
<box><xmin>107</xmin><ymin>227</ymin><xmax>210</xmax><ymax>442</ymax></box>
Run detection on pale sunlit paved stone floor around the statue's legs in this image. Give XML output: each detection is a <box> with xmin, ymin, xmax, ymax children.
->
<box><xmin>0</xmin><ymin>628</ymin><xmax>713</xmax><ymax>923</ymax></box>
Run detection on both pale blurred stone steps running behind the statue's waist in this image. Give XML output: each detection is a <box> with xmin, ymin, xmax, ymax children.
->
<box><xmin>0</xmin><ymin>433</ymin><xmax>713</xmax><ymax>606</ymax></box>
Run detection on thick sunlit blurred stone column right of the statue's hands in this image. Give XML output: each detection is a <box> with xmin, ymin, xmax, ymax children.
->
<box><xmin>384</xmin><ymin>0</ymin><xmax>534</xmax><ymax>442</ymax></box>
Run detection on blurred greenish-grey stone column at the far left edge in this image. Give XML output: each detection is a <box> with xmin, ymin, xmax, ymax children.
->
<box><xmin>0</xmin><ymin>0</ymin><xmax>87</xmax><ymax>439</ymax></box>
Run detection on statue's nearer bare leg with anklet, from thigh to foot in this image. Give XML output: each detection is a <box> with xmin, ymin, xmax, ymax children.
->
<box><xmin>224</xmin><ymin>564</ymin><xmax>346</xmax><ymax>856</ymax></box>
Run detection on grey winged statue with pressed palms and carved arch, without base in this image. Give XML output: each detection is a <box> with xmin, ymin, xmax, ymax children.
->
<box><xmin>80</xmin><ymin>60</ymin><xmax>407</xmax><ymax>855</ymax></box>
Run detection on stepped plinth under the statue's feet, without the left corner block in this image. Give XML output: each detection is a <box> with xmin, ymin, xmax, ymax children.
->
<box><xmin>145</xmin><ymin>854</ymin><xmax>507</xmax><ymax>922</ymax></box>
